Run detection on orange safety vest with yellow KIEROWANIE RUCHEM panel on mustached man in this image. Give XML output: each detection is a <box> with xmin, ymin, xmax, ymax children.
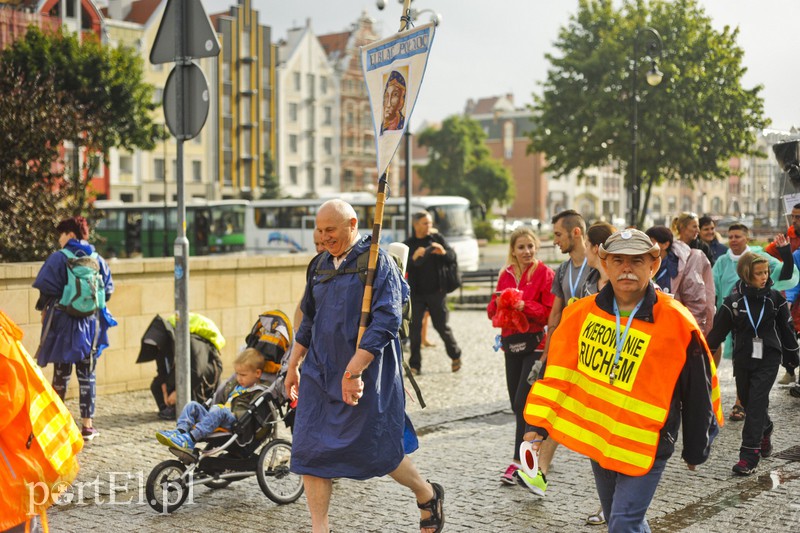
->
<box><xmin>525</xmin><ymin>292</ymin><xmax>722</xmax><ymax>476</ymax></box>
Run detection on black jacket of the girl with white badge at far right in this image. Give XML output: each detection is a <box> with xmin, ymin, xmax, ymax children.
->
<box><xmin>707</xmin><ymin>278</ymin><xmax>798</xmax><ymax>369</ymax></box>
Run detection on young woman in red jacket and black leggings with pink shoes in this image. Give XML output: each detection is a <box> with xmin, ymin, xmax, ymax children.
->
<box><xmin>486</xmin><ymin>227</ymin><xmax>555</xmax><ymax>485</ymax></box>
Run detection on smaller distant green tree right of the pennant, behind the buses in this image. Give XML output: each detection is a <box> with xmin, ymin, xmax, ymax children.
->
<box><xmin>417</xmin><ymin>115</ymin><xmax>514</xmax><ymax>213</ymax></box>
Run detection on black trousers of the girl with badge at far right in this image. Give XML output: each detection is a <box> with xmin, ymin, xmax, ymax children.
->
<box><xmin>735</xmin><ymin>362</ymin><xmax>780</xmax><ymax>450</ymax></box>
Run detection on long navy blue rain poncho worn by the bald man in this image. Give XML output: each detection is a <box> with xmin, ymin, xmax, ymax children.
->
<box><xmin>292</xmin><ymin>237</ymin><xmax>416</xmax><ymax>479</ymax></box>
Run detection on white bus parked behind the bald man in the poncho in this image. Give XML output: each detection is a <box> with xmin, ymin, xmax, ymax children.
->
<box><xmin>245</xmin><ymin>193</ymin><xmax>479</xmax><ymax>271</ymax></box>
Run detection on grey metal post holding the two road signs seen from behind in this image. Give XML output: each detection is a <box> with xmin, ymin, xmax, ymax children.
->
<box><xmin>174</xmin><ymin>1</ymin><xmax>191</xmax><ymax>412</ymax></box>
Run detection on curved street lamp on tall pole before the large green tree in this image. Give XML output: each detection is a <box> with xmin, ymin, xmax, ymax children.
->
<box><xmin>629</xmin><ymin>27</ymin><xmax>664</xmax><ymax>227</ymax></box>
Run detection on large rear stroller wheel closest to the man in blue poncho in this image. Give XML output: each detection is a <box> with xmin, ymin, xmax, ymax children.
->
<box><xmin>256</xmin><ymin>439</ymin><xmax>303</xmax><ymax>504</ymax></box>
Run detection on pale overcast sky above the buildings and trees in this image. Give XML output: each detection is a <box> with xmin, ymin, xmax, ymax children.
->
<box><xmin>202</xmin><ymin>0</ymin><xmax>800</xmax><ymax>130</ymax></box>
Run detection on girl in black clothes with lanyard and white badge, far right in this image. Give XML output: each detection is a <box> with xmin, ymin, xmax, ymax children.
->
<box><xmin>707</xmin><ymin>252</ymin><xmax>798</xmax><ymax>476</ymax></box>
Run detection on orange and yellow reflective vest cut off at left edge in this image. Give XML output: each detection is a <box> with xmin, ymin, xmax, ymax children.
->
<box><xmin>0</xmin><ymin>311</ymin><xmax>83</xmax><ymax>531</ymax></box>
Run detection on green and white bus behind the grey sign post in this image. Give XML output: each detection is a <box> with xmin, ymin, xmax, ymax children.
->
<box><xmin>94</xmin><ymin>200</ymin><xmax>247</xmax><ymax>258</ymax></box>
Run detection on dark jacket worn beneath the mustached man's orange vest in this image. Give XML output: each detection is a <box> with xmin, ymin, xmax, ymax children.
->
<box><xmin>530</xmin><ymin>283</ymin><xmax>719</xmax><ymax>465</ymax></box>
